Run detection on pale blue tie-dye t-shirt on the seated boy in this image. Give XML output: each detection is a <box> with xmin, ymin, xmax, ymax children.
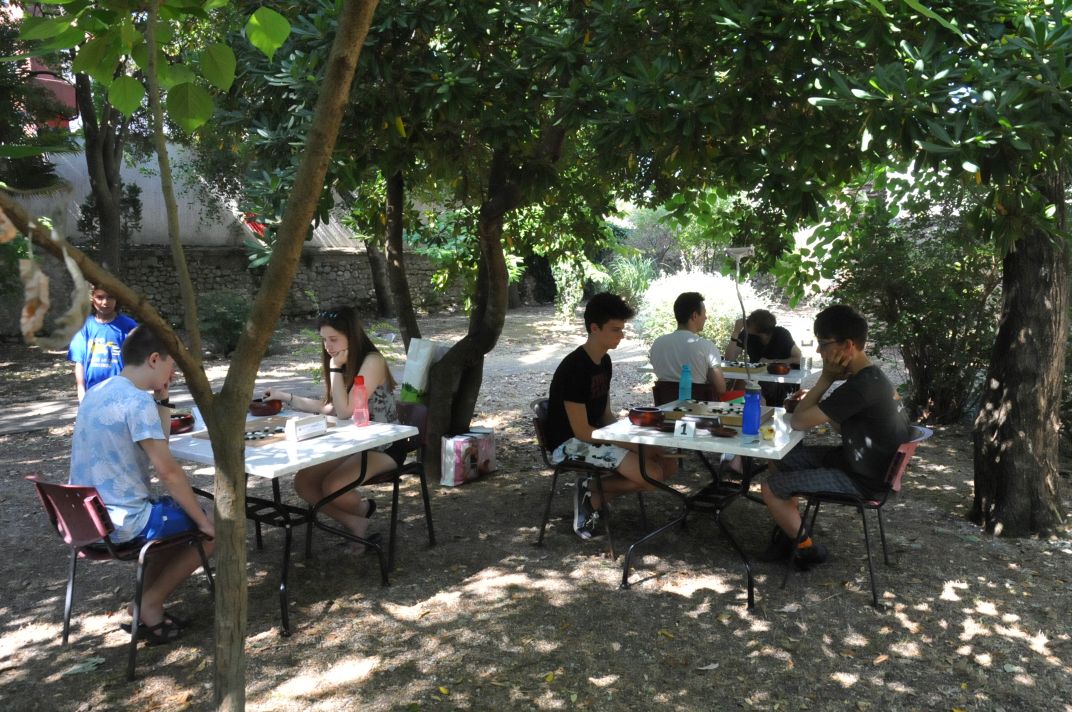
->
<box><xmin>71</xmin><ymin>376</ymin><xmax>164</xmax><ymax>543</ymax></box>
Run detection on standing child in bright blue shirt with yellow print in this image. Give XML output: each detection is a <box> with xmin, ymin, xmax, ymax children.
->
<box><xmin>68</xmin><ymin>286</ymin><xmax>137</xmax><ymax>403</ymax></box>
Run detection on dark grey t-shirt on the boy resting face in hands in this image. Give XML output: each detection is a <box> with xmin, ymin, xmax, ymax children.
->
<box><xmin>819</xmin><ymin>366</ymin><xmax>911</xmax><ymax>491</ymax></box>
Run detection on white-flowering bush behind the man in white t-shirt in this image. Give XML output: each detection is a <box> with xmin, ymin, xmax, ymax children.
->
<box><xmin>634</xmin><ymin>272</ymin><xmax>760</xmax><ymax>350</ymax></box>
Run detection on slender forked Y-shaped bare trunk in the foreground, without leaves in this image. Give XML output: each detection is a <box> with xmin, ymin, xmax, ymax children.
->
<box><xmin>0</xmin><ymin>0</ymin><xmax>377</xmax><ymax>710</ymax></box>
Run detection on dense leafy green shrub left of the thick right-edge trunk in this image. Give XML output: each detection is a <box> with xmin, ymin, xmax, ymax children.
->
<box><xmin>802</xmin><ymin>171</ymin><xmax>1001</xmax><ymax>422</ymax></box>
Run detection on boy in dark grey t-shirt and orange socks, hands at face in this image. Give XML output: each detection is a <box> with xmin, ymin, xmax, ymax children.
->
<box><xmin>762</xmin><ymin>305</ymin><xmax>911</xmax><ymax>568</ymax></box>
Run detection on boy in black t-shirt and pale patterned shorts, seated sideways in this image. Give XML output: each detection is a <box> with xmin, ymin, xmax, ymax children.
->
<box><xmin>547</xmin><ymin>293</ymin><xmax>676</xmax><ymax>539</ymax></box>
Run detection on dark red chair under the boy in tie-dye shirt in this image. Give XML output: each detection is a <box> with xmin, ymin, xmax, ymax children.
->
<box><xmin>27</xmin><ymin>475</ymin><xmax>214</xmax><ymax>680</ymax></box>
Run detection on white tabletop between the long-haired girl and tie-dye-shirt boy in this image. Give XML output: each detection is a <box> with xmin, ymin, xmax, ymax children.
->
<box><xmin>168</xmin><ymin>411</ymin><xmax>419</xmax><ymax>479</ymax></box>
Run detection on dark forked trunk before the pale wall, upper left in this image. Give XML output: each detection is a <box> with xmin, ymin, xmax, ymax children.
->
<box><xmin>74</xmin><ymin>74</ymin><xmax>126</xmax><ymax>275</ymax></box>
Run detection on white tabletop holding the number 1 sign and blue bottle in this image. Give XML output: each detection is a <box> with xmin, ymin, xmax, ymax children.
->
<box><xmin>592</xmin><ymin>403</ymin><xmax>804</xmax><ymax>460</ymax></box>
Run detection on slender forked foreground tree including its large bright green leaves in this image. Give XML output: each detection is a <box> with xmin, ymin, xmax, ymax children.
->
<box><xmin>0</xmin><ymin>0</ymin><xmax>376</xmax><ymax>709</ymax></box>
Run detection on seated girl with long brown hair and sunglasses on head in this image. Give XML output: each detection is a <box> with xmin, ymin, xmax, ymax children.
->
<box><xmin>264</xmin><ymin>307</ymin><xmax>398</xmax><ymax>551</ymax></box>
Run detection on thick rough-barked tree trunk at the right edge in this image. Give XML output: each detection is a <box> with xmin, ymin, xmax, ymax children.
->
<box><xmin>968</xmin><ymin>180</ymin><xmax>1069</xmax><ymax>536</ymax></box>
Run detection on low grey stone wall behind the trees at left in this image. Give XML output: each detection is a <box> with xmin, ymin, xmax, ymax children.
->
<box><xmin>0</xmin><ymin>246</ymin><xmax>462</xmax><ymax>337</ymax></box>
